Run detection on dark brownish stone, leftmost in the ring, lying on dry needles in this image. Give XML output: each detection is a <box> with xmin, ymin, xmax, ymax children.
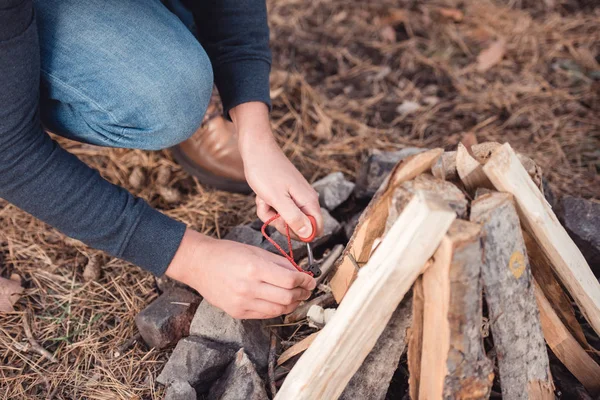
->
<box><xmin>135</xmin><ymin>288</ymin><xmax>201</xmax><ymax>350</ymax></box>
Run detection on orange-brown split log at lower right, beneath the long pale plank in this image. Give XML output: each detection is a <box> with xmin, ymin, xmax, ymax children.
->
<box><xmin>534</xmin><ymin>282</ymin><xmax>600</xmax><ymax>398</ymax></box>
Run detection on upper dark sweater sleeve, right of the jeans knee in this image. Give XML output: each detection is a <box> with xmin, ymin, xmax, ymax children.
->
<box><xmin>187</xmin><ymin>0</ymin><xmax>271</xmax><ymax>117</ymax></box>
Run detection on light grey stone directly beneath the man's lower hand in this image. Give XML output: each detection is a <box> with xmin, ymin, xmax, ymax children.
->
<box><xmin>190</xmin><ymin>300</ymin><xmax>270</xmax><ymax>372</ymax></box>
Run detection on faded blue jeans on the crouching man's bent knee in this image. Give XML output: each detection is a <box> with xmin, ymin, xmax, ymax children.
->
<box><xmin>34</xmin><ymin>0</ymin><xmax>213</xmax><ymax>150</ymax></box>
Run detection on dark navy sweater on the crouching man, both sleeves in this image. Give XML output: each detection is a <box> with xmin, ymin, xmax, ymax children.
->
<box><xmin>0</xmin><ymin>0</ymin><xmax>271</xmax><ymax>275</ymax></box>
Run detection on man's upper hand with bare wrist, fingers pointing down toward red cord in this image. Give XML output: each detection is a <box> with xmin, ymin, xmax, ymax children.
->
<box><xmin>230</xmin><ymin>102</ymin><xmax>323</xmax><ymax>238</ymax></box>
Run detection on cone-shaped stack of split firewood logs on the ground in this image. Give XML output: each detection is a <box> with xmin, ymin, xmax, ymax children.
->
<box><xmin>276</xmin><ymin>143</ymin><xmax>600</xmax><ymax>400</ymax></box>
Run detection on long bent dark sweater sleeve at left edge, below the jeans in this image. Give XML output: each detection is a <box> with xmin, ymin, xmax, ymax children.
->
<box><xmin>0</xmin><ymin>0</ymin><xmax>185</xmax><ymax>275</ymax></box>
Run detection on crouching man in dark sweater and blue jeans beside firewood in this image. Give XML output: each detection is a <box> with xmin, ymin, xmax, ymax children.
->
<box><xmin>0</xmin><ymin>0</ymin><xmax>323</xmax><ymax>318</ymax></box>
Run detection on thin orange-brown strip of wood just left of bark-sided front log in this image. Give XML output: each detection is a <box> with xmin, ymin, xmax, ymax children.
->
<box><xmin>408</xmin><ymin>276</ymin><xmax>427</xmax><ymax>400</ymax></box>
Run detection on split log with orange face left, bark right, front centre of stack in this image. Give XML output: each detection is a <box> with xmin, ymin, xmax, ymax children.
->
<box><xmin>419</xmin><ymin>220</ymin><xmax>492</xmax><ymax>399</ymax></box>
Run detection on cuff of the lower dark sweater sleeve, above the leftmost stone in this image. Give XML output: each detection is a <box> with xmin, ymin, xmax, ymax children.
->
<box><xmin>120</xmin><ymin>206</ymin><xmax>186</xmax><ymax>276</ymax></box>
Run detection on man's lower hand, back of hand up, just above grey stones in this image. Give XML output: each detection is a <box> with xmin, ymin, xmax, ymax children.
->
<box><xmin>166</xmin><ymin>229</ymin><xmax>316</xmax><ymax>319</ymax></box>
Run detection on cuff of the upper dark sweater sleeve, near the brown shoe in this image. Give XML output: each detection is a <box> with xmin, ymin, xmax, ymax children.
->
<box><xmin>214</xmin><ymin>59</ymin><xmax>271</xmax><ymax>119</ymax></box>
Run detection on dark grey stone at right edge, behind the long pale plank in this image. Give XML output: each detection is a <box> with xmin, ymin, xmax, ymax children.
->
<box><xmin>558</xmin><ymin>196</ymin><xmax>600</xmax><ymax>278</ymax></box>
